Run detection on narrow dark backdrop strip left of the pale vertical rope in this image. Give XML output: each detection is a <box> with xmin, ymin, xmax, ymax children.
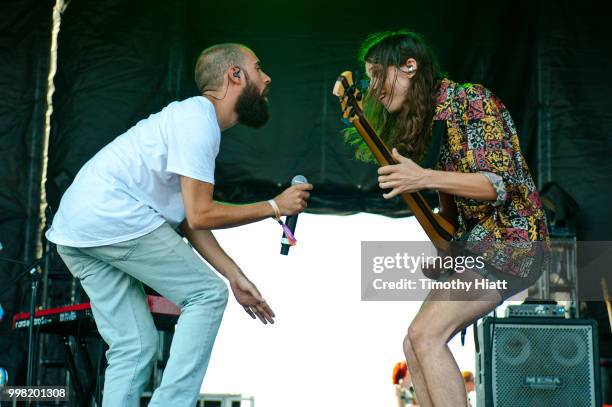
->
<box><xmin>0</xmin><ymin>0</ymin><xmax>52</xmax><ymax>380</ymax></box>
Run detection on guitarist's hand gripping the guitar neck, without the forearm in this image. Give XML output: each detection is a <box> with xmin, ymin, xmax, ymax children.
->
<box><xmin>378</xmin><ymin>148</ymin><xmax>427</xmax><ymax>199</ymax></box>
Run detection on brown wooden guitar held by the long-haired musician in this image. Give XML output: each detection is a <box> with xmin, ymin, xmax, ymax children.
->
<box><xmin>333</xmin><ymin>71</ymin><xmax>457</xmax><ymax>251</ymax></box>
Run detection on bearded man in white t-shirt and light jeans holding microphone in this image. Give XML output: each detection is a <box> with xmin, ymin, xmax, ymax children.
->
<box><xmin>47</xmin><ymin>44</ymin><xmax>312</xmax><ymax>407</ymax></box>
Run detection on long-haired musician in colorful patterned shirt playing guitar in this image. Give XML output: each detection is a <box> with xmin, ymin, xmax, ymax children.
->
<box><xmin>353</xmin><ymin>30</ymin><xmax>548</xmax><ymax>407</ymax></box>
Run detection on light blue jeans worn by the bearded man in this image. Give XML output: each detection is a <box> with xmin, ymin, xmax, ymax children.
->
<box><xmin>57</xmin><ymin>224</ymin><xmax>228</xmax><ymax>407</ymax></box>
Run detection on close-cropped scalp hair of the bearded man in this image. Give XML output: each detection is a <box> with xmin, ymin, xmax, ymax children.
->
<box><xmin>195</xmin><ymin>43</ymin><xmax>252</xmax><ymax>92</ymax></box>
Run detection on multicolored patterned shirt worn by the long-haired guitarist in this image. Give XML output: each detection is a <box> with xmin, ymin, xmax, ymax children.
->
<box><xmin>434</xmin><ymin>79</ymin><xmax>548</xmax><ymax>277</ymax></box>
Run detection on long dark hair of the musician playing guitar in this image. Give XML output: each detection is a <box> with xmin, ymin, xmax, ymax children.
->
<box><xmin>345</xmin><ymin>30</ymin><xmax>444</xmax><ymax>162</ymax></box>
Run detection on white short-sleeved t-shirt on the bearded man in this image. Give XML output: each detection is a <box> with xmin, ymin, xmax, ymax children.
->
<box><xmin>46</xmin><ymin>96</ymin><xmax>221</xmax><ymax>247</ymax></box>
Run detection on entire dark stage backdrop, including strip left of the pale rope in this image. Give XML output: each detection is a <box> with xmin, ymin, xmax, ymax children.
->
<box><xmin>0</xmin><ymin>0</ymin><xmax>612</xmax><ymax>386</ymax></box>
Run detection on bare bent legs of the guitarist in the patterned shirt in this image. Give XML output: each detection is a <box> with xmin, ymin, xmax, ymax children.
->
<box><xmin>404</xmin><ymin>271</ymin><xmax>501</xmax><ymax>407</ymax></box>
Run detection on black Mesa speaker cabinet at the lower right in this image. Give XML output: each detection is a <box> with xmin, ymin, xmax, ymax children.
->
<box><xmin>476</xmin><ymin>317</ymin><xmax>601</xmax><ymax>407</ymax></box>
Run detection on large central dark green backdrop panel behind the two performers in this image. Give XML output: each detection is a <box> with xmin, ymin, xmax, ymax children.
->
<box><xmin>48</xmin><ymin>0</ymin><xmax>538</xmax><ymax>215</ymax></box>
